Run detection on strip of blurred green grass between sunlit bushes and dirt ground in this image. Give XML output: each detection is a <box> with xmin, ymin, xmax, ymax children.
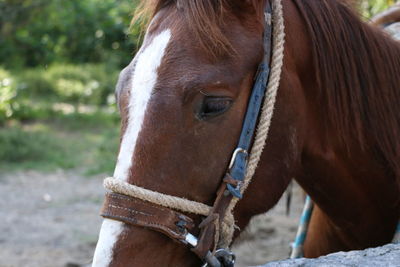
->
<box><xmin>0</xmin><ymin>112</ymin><xmax>119</xmax><ymax>174</ymax></box>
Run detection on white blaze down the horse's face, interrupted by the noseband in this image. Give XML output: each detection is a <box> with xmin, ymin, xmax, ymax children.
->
<box><xmin>92</xmin><ymin>29</ymin><xmax>171</xmax><ymax>267</ymax></box>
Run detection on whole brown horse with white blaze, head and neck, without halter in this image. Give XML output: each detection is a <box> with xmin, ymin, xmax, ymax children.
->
<box><xmin>93</xmin><ymin>0</ymin><xmax>400</xmax><ymax>266</ymax></box>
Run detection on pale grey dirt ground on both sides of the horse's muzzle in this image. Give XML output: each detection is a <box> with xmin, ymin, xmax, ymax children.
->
<box><xmin>0</xmin><ymin>171</ymin><xmax>302</xmax><ymax>267</ymax></box>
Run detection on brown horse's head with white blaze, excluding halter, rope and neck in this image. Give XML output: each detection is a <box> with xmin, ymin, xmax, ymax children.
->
<box><xmin>94</xmin><ymin>0</ymin><xmax>302</xmax><ymax>266</ymax></box>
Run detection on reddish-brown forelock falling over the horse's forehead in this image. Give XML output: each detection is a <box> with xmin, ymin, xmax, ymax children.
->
<box><xmin>132</xmin><ymin>0</ymin><xmax>265</xmax><ymax>58</ymax></box>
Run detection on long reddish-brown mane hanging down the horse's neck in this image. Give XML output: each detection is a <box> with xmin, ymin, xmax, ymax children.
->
<box><xmin>294</xmin><ymin>0</ymin><xmax>400</xmax><ymax>178</ymax></box>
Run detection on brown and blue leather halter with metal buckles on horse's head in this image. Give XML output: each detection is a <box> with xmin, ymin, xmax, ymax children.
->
<box><xmin>101</xmin><ymin>1</ymin><xmax>272</xmax><ymax>267</ymax></box>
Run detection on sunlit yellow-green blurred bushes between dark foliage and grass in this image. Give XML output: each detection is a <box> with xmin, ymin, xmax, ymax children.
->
<box><xmin>0</xmin><ymin>64</ymin><xmax>118</xmax><ymax>125</ymax></box>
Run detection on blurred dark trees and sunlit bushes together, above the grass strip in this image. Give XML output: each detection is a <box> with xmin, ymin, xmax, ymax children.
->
<box><xmin>0</xmin><ymin>0</ymin><xmax>140</xmax><ymax>125</ymax></box>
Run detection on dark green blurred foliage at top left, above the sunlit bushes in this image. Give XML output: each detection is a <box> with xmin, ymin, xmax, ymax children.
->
<box><xmin>0</xmin><ymin>0</ymin><xmax>140</xmax><ymax>68</ymax></box>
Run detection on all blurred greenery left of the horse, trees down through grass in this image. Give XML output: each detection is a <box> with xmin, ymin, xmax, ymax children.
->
<box><xmin>0</xmin><ymin>0</ymin><xmax>135</xmax><ymax>173</ymax></box>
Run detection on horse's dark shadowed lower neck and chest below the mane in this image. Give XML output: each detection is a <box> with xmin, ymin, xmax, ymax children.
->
<box><xmin>296</xmin><ymin>118</ymin><xmax>400</xmax><ymax>257</ymax></box>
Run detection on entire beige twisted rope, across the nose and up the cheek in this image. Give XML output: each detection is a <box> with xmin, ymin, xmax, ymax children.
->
<box><xmin>104</xmin><ymin>0</ymin><xmax>285</xmax><ymax>251</ymax></box>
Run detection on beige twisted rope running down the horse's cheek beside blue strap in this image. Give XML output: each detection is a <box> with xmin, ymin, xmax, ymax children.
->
<box><xmin>220</xmin><ymin>0</ymin><xmax>285</xmax><ymax>247</ymax></box>
